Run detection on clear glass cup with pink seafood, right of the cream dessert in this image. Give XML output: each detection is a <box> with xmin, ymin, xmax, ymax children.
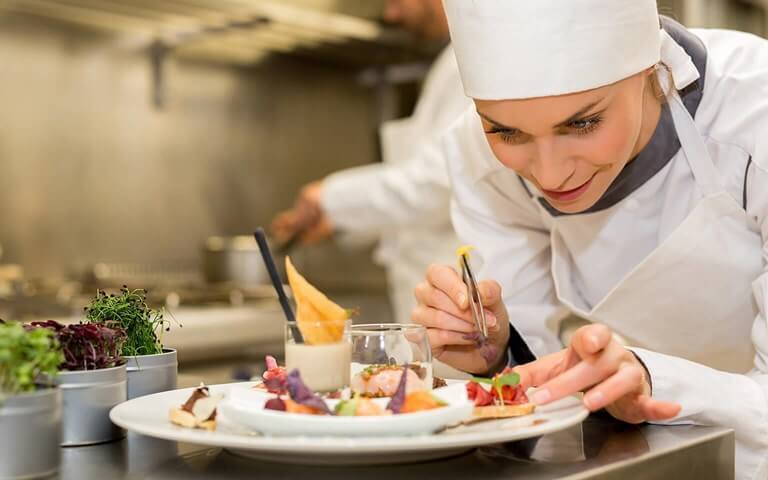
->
<box><xmin>349</xmin><ymin>323</ymin><xmax>433</xmax><ymax>396</ymax></box>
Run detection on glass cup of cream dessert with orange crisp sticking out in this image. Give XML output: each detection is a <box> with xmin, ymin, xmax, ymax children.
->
<box><xmin>285</xmin><ymin>320</ymin><xmax>351</xmax><ymax>393</ymax></box>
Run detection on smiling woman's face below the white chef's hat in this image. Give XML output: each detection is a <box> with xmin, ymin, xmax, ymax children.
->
<box><xmin>475</xmin><ymin>70</ymin><xmax>660</xmax><ymax>213</ymax></box>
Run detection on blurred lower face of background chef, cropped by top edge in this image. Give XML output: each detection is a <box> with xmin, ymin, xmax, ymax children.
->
<box><xmin>383</xmin><ymin>0</ymin><xmax>448</xmax><ymax>40</ymax></box>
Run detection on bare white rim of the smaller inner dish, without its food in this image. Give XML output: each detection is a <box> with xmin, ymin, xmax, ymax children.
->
<box><xmin>218</xmin><ymin>384</ymin><xmax>474</xmax><ymax>437</ymax></box>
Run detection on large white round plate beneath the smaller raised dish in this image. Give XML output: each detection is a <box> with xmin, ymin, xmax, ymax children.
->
<box><xmin>110</xmin><ymin>382</ymin><xmax>589</xmax><ymax>465</ymax></box>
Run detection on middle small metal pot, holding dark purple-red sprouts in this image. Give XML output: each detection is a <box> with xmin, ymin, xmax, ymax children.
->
<box><xmin>57</xmin><ymin>365</ymin><xmax>127</xmax><ymax>447</ymax></box>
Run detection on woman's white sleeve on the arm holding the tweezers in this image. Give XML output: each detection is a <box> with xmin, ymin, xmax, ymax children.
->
<box><xmin>443</xmin><ymin>111</ymin><xmax>562</xmax><ymax>356</ymax></box>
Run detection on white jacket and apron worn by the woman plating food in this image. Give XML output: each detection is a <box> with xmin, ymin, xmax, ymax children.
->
<box><xmin>442</xmin><ymin>20</ymin><xmax>768</xmax><ymax>479</ymax></box>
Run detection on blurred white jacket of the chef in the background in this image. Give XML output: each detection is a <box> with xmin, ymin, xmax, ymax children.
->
<box><xmin>321</xmin><ymin>47</ymin><xmax>470</xmax><ymax>323</ymax></box>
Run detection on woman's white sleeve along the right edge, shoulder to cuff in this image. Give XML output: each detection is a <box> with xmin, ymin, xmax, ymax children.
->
<box><xmin>624</xmin><ymin>30</ymin><xmax>768</xmax><ymax>479</ymax></box>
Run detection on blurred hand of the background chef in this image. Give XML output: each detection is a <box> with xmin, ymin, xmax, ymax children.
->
<box><xmin>271</xmin><ymin>181</ymin><xmax>333</xmax><ymax>244</ymax></box>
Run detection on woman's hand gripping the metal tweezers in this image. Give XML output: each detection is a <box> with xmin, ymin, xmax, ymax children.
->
<box><xmin>412</xmin><ymin>265</ymin><xmax>509</xmax><ymax>374</ymax></box>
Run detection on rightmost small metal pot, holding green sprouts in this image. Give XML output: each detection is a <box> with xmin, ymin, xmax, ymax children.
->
<box><xmin>125</xmin><ymin>348</ymin><xmax>179</xmax><ymax>400</ymax></box>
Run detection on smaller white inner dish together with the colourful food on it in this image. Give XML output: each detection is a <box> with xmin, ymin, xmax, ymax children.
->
<box><xmin>212</xmin><ymin>359</ymin><xmax>474</xmax><ymax>436</ymax></box>
